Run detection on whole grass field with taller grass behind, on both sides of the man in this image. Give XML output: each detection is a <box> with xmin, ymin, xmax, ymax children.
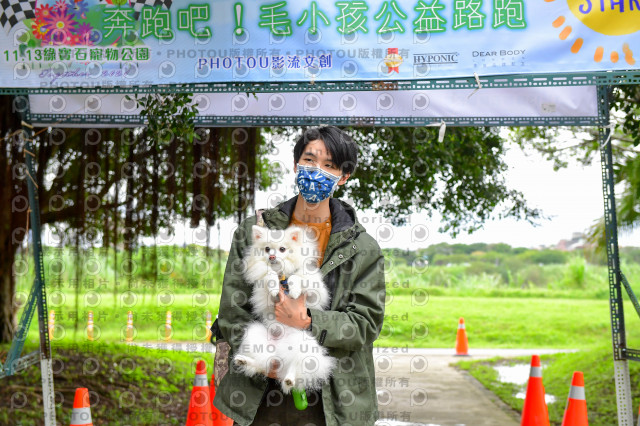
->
<box><xmin>8</xmin><ymin>246</ymin><xmax>640</xmax><ymax>425</ymax></box>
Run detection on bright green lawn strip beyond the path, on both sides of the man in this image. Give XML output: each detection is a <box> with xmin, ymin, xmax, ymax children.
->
<box><xmin>20</xmin><ymin>293</ymin><xmax>640</xmax><ymax>349</ymax></box>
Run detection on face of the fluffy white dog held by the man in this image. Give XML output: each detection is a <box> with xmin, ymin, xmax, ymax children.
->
<box><xmin>251</xmin><ymin>225</ymin><xmax>303</xmax><ymax>276</ymax></box>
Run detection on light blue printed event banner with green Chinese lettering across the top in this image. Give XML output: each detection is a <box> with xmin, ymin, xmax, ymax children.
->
<box><xmin>0</xmin><ymin>0</ymin><xmax>640</xmax><ymax>88</ymax></box>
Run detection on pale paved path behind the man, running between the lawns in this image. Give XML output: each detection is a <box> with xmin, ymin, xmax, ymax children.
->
<box><xmin>131</xmin><ymin>343</ymin><xmax>568</xmax><ymax>426</ymax></box>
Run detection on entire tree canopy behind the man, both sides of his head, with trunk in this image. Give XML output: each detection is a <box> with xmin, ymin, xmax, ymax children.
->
<box><xmin>0</xmin><ymin>110</ymin><xmax>552</xmax><ymax>341</ymax></box>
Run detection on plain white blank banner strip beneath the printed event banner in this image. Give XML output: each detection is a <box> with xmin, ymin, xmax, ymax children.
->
<box><xmin>29</xmin><ymin>86</ymin><xmax>598</xmax><ymax>127</ymax></box>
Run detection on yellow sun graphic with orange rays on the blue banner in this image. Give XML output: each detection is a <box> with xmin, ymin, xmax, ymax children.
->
<box><xmin>545</xmin><ymin>0</ymin><xmax>640</xmax><ymax>65</ymax></box>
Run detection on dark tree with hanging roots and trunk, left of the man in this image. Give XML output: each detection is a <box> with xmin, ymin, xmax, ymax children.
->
<box><xmin>0</xmin><ymin>94</ymin><xmax>275</xmax><ymax>342</ymax></box>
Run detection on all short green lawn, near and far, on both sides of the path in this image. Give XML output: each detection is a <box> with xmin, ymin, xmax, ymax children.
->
<box><xmin>8</xmin><ymin>274</ymin><xmax>640</xmax><ymax>425</ymax></box>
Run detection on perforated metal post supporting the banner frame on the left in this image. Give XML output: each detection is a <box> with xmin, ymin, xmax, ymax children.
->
<box><xmin>22</xmin><ymin>105</ymin><xmax>56</xmax><ymax>426</ymax></box>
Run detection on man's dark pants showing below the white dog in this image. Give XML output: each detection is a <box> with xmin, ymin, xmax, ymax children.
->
<box><xmin>233</xmin><ymin>378</ymin><xmax>326</xmax><ymax>426</ymax></box>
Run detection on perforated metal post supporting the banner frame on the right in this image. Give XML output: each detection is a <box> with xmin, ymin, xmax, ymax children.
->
<box><xmin>598</xmin><ymin>86</ymin><xmax>633</xmax><ymax>426</ymax></box>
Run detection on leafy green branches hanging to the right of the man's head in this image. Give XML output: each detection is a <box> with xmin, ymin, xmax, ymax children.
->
<box><xmin>272</xmin><ymin>127</ymin><xmax>542</xmax><ymax>236</ymax></box>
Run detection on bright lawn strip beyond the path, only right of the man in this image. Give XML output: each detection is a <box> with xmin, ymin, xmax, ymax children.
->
<box><xmin>378</xmin><ymin>296</ymin><xmax>640</xmax><ymax>349</ymax></box>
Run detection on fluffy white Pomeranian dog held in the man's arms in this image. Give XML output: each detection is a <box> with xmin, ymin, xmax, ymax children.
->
<box><xmin>233</xmin><ymin>225</ymin><xmax>336</xmax><ymax>394</ymax></box>
